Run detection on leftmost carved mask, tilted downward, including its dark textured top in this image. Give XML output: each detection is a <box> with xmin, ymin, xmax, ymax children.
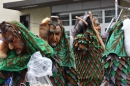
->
<box><xmin>1</xmin><ymin>23</ymin><xmax>24</xmax><ymax>54</ymax></box>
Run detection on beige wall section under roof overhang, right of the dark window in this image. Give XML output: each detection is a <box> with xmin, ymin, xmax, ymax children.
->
<box><xmin>20</xmin><ymin>7</ymin><xmax>51</xmax><ymax>35</ymax></box>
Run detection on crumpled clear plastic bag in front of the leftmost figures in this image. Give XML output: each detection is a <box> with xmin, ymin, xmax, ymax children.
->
<box><xmin>26</xmin><ymin>51</ymin><xmax>52</xmax><ymax>86</ymax></box>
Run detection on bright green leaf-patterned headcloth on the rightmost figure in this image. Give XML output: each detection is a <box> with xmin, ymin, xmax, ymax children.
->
<box><xmin>103</xmin><ymin>21</ymin><xmax>127</xmax><ymax>57</ymax></box>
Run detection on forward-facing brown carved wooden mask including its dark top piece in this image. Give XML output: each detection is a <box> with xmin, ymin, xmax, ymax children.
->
<box><xmin>48</xmin><ymin>17</ymin><xmax>63</xmax><ymax>47</ymax></box>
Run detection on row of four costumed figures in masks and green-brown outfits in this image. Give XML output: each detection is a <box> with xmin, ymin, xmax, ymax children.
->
<box><xmin>0</xmin><ymin>13</ymin><xmax>130</xmax><ymax>86</ymax></box>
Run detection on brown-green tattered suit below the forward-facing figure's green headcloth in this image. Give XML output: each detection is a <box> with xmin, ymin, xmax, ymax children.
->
<box><xmin>50</xmin><ymin>56</ymin><xmax>78</xmax><ymax>86</ymax></box>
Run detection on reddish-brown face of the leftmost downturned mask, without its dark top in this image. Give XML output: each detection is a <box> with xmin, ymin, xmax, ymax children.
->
<box><xmin>4</xmin><ymin>27</ymin><xmax>24</xmax><ymax>54</ymax></box>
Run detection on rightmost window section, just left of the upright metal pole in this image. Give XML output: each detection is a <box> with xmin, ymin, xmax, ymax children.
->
<box><xmin>105</xmin><ymin>10</ymin><xmax>115</xmax><ymax>23</ymax></box>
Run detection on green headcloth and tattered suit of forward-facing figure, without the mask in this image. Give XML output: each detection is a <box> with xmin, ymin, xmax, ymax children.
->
<box><xmin>51</xmin><ymin>27</ymin><xmax>78</xmax><ymax>86</ymax></box>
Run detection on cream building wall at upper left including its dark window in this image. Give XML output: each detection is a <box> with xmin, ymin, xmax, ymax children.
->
<box><xmin>0</xmin><ymin>0</ymin><xmax>51</xmax><ymax>35</ymax></box>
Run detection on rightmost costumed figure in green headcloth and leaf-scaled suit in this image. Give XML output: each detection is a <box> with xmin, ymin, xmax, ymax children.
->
<box><xmin>101</xmin><ymin>18</ymin><xmax>130</xmax><ymax>86</ymax></box>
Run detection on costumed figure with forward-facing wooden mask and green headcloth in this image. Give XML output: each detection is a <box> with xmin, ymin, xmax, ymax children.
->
<box><xmin>40</xmin><ymin>16</ymin><xmax>78</xmax><ymax>86</ymax></box>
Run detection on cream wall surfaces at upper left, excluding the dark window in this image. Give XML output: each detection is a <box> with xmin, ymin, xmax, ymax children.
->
<box><xmin>0</xmin><ymin>0</ymin><xmax>51</xmax><ymax>35</ymax></box>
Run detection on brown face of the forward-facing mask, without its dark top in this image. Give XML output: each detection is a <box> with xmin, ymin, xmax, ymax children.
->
<box><xmin>48</xmin><ymin>25</ymin><xmax>62</xmax><ymax>47</ymax></box>
